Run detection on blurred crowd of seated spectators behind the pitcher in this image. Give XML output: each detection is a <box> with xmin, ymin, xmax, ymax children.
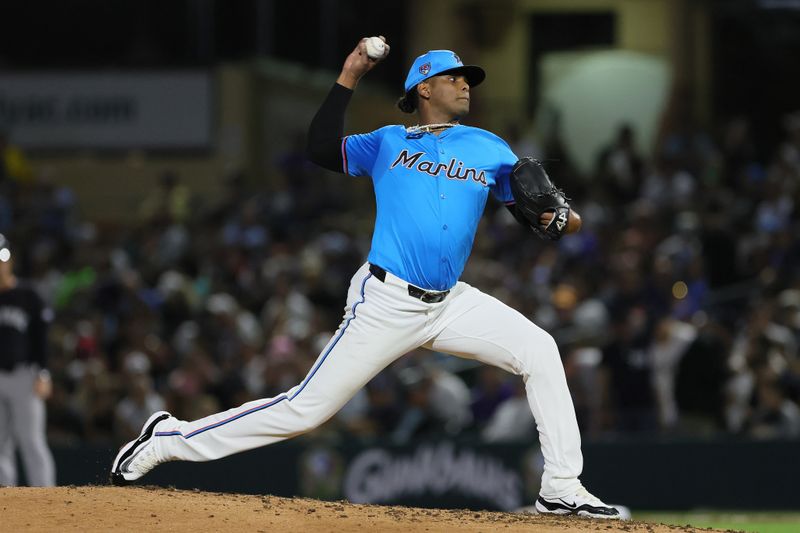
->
<box><xmin>0</xmin><ymin>109</ymin><xmax>800</xmax><ymax>444</ymax></box>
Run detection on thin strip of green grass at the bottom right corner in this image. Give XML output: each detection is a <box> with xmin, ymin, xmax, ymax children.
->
<box><xmin>633</xmin><ymin>511</ymin><xmax>800</xmax><ymax>533</ymax></box>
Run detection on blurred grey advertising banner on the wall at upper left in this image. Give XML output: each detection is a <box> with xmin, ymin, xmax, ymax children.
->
<box><xmin>0</xmin><ymin>72</ymin><xmax>212</xmax><ymax>149</ymax></box>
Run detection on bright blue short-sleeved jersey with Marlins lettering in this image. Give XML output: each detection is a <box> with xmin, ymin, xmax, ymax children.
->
<box><xmin>342</xmin><ymin>125</ymin><xmax>518</xmax><ymax>291</ymax></box>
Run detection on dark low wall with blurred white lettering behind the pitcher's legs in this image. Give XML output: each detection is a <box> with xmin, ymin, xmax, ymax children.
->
<box><xmin>42</xmin><ymin>438</ymin><xmax>800</xmax><ymax>510</ymax></box>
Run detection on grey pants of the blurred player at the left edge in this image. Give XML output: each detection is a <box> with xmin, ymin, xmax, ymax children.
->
<box><xmin>0</xmin><ymin>365</ymin><xmax>56</xmax><ymax>487</ymax></box>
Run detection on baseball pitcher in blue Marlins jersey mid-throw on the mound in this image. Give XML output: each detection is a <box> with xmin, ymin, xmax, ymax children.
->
<box><xmin>111</xmin><ymin>39</ymin><xmax>619</xmax><ymax>518</ymax></box>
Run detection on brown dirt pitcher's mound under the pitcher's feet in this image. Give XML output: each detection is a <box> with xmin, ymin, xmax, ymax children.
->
<box><xmin>0</xmin><ymin>486</ymin><xmax>720</xmax><ymax>533</ymax></box>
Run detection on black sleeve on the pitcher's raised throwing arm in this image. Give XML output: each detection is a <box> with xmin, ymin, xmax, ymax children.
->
<box><xmin>307</xmin><ymin>83</ymin><xmax>353</xmax><ymax>173</ymax></box>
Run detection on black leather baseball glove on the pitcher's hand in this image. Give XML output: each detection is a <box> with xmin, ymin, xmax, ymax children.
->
<box><xmin>511</xmin><ymin>157</ymin><xmax>570</xmax><ymax>241</ymax></box>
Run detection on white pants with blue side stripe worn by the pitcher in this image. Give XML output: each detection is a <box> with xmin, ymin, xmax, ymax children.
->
<box><xmin>154</xmin><ymin>264</ymin><xmax>583</xmax><ymax>497</ymax></box>
